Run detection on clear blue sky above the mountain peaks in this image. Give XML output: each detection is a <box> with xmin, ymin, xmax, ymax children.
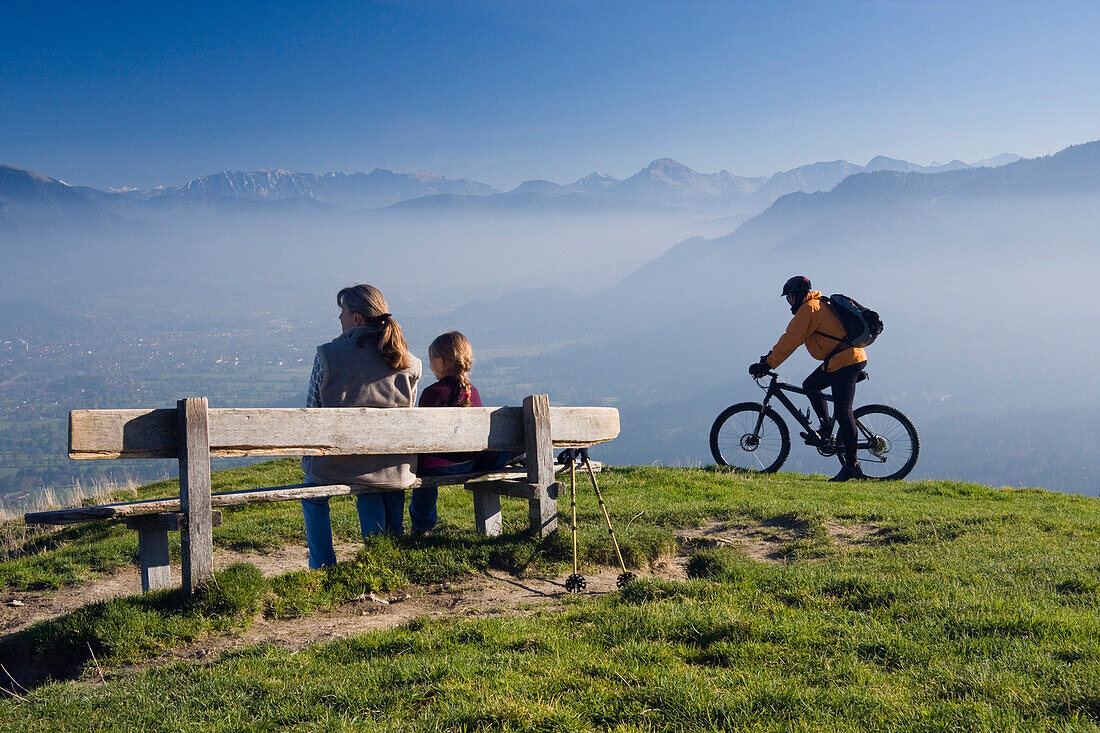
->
<box><xmin>0</xmin><ymin>0</ymin><xmax>1100</xmax><ymax>188</ymax></box>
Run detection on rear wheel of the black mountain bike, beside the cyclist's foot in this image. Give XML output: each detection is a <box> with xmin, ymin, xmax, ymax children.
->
<box><xmin>855</xmin><ymin>405</ymin><xmax>921</xmax><ymax>481</ymax></box>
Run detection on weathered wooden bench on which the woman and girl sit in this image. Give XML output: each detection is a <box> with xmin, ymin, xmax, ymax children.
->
<box><xmin>24</xmin><ymin>395</ymin><xmax>619</xmax><ymax>595</ymax></box>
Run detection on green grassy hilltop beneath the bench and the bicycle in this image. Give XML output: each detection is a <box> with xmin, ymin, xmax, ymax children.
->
<box><xmin>0</xmin><ymin>461</ymin><xmax>1100</xmax><ymax>731</ymax></box>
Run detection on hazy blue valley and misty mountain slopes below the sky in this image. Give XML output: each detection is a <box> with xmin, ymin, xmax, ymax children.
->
<box><xmin>0</xmin><ymin>142</ymin><xmax>1100</xmax><ymax>499</ymax></box>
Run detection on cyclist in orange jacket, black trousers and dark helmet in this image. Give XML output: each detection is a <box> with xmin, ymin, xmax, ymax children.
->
<box><xmin>749</xmin><ymin>275</ymin><xmax>867</xmax><ymax>481</ymax></box>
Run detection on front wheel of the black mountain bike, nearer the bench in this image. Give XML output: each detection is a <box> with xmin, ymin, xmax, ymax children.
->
<box><xmin>711</xmin><ymin>402</ymin><xmax>791</xmax><ymax>473</ymax></box>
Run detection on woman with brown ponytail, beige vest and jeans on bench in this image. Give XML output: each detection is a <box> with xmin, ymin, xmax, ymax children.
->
<box><xmin>301</xmin><ymin>285</ymin><xmax>420</xmax><ymax>568</ymax></box>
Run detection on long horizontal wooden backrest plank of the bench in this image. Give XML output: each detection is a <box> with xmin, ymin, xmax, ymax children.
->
<box><xmin>69</xmin><ymin>407</ymin><xmax>619</xmax><ymax>459</ymax></box>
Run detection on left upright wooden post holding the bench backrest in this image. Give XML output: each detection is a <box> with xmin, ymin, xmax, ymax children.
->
<box><xmin>176</xmin><ymin>397</ymin><xmax>213</xmax><ymax>595</ymax></box>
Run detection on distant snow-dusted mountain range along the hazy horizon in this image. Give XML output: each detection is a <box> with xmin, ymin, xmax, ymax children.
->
<box><xmin>0</xmin><ymin>154</ymin><xmax>1020</xmax><ymax>221</ymax></box>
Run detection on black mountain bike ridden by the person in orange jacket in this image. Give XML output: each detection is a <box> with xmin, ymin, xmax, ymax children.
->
<box><xmin>711</xmin><ymin>371</ymin><xmax>921</xmax><ymax>481</ymax></box>
